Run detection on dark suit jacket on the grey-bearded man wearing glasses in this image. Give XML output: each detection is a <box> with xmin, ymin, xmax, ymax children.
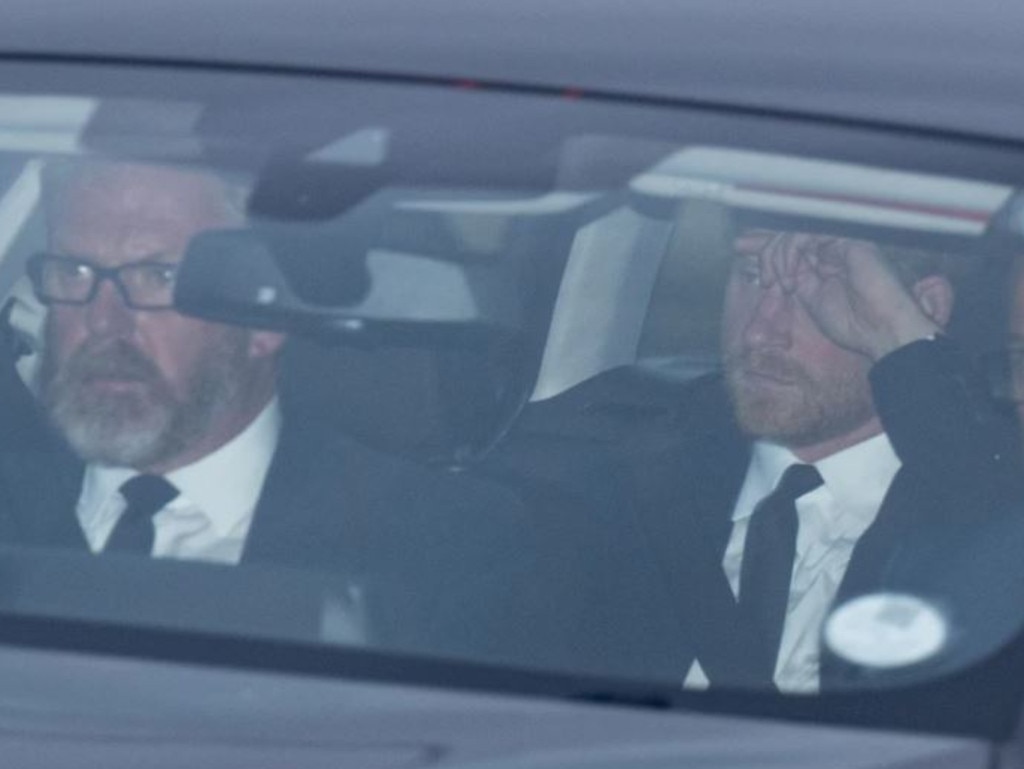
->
<box><xmin>0</xmin><ymin>376</ymin><xmax>577</xmax><ymax>668</ymax></box>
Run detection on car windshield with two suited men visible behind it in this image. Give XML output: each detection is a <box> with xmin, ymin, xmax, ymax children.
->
<box><xmin>0</xmin><ymin>65</ymin><xmax>1024</xmax><ymax>720</ymax></box>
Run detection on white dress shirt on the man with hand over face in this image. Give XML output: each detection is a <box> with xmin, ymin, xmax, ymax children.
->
<box><xmin>685</xmin><ymin>433</ymin><xmax>900</xmax><ymax>692</ymax></box>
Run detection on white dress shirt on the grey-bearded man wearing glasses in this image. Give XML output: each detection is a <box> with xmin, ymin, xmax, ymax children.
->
<box><xmin>77</xmin><ymin>399</ymin><xmax>281</xmax><ymax>564</ymax></box>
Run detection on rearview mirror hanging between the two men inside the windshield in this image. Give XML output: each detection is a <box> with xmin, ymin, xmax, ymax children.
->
<box><xmin>175</xmin><ymin>225</ymin><xmax>521</xmax><ymax>345</ymax></box>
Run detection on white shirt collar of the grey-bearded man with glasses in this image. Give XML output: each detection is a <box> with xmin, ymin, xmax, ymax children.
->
<box><xmin>81</xmin><ymin>398</ymin><xmax>282</xmax><ymax>537</ymax></box>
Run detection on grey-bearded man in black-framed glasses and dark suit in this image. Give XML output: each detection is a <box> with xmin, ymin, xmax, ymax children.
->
<box><xmin>0</xmin><ymin>161</ymin><xmax>562</xmax><ymax>671</ymax></box>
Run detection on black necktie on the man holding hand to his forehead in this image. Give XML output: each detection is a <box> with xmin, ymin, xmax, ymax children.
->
<box><xmin>739</xmin><ymin>465</ymin><xmax>822</xmax><ymax>686</ymax></box>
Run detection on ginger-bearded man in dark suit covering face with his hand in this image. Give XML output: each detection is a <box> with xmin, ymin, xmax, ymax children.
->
<box><xmin>602</xmin><ymin>229</ymin><xmax>1005</xmax><ymax>691</ymax></box>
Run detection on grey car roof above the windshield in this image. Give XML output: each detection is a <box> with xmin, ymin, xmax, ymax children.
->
<box><xmin>0</xmin><ymin>0</ymin><xmax>1024</xmax><ymax>141</ymax></box>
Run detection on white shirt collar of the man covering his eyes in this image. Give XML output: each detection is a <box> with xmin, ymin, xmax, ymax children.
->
<box><xmin>732</xmin><ymin>433</ymin><xmax>900</xmax><ymax>521</ymax></box>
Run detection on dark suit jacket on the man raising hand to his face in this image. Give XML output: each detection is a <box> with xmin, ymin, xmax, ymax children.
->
<box><xmin>629</xmin><ymin>340</ymin><xmax>1019</xmax><ymax>688</ymax></box>
